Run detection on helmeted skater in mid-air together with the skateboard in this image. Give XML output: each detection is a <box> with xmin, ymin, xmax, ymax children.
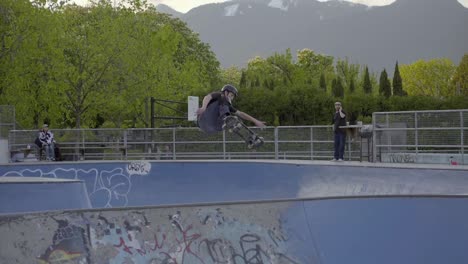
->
<box><xmin>197</xmin><ymin>84</ymin><xmax>265</xmax><ymax>147</ymax></box>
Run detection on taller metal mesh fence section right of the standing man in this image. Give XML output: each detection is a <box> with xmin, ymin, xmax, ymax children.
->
<box><xmin>372</xmin><ymin>109</ymin><xmax>468</xmax><ymax>165</ymax></box>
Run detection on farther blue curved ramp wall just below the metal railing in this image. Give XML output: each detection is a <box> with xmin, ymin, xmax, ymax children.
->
<box><xmin>0</xmin><ymin>161</ymin><xmax>468</xmax><ymax>209</ymax></box>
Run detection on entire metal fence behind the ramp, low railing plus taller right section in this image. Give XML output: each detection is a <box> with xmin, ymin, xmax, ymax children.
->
<box><xmin>8</xmin><ymin>109</ymin><xmax>468</xmax><ymax>165</ymax></box>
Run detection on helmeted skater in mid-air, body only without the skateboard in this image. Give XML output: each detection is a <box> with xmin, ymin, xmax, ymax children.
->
<box><xmin>197</xmin><ymin>84</ymin><xmax>265</xmax><ymax>133</ymax></box>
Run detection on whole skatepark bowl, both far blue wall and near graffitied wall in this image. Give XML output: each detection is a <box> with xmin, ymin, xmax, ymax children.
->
<box><xmin>0</xmin><ymin>161</ymin><xmax>468</xmax><ymax>264</ymax></box>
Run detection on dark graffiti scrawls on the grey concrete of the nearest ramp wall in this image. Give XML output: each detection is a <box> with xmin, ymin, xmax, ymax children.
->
<box><xmin>9</xmin><ymin>207</ymin><xmax>299</xmax><ymax>264</ymax></box>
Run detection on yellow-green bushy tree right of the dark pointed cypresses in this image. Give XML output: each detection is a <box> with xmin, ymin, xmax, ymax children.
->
<box><xmin>400</xmin><ymin>58</ymin><xmax>456</xmax><ymax>98</ymax></box>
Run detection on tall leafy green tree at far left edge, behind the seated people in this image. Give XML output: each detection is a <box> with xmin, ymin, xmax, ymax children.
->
<box><xmin>0</xmin><ymin>0</ymin><xmax>62</xmax><ymax>128</ymax></box>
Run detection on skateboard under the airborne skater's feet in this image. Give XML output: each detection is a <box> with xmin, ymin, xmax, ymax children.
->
<box><xmin>223</xmin><ymin>115</ymin><xmax>264</xmax><ymax>149</ymax></box>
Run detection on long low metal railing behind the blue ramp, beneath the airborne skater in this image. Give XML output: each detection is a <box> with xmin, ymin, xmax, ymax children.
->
<box><xmin>9</xmin><ymin>126</ymin><xmax>361</xmax><ymax>160</ymax></box>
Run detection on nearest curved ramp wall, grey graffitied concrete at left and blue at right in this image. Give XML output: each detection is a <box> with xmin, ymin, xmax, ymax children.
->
<box><xmin>0</xmin><ymin>196</ymin><xmax>468</xmax><ymax>264</ymax></box>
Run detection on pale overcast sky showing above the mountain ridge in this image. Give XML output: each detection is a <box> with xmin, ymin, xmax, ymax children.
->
<box><xmin>72</xmin><ymin>0</ymin><xmax>468</xmax><ymax>13</ymax></box>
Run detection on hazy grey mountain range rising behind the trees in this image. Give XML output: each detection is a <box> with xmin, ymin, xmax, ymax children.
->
<box><xmin>157</xmin><ymin>0</ymin><xmax>468</xmax><ymax>72</ymax></box>
